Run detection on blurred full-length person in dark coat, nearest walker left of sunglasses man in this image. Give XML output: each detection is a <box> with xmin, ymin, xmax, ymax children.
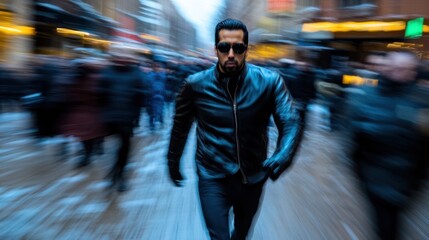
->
<box><xmin>99</xmin><ymin>45</ymin><xmax>143</xmax><ymax>192</ymax></box>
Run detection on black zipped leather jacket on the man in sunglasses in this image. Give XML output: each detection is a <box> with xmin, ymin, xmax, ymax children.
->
<box><xmin>167</xmin><ymin>64</ymin><xmax>302</xmax><ymax>183</ymax></box>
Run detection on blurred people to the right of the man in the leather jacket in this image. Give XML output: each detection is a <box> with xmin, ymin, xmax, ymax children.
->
<box><xmin>270</xmin><ymin>50</ymin><xmax>429</xmax><ymax>239</ymax></box>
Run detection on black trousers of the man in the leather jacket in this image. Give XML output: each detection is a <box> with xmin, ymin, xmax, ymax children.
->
<box><xmin>198</xmin><ymin>173</ymin><xmax>264</xmax><ymax>240</ymax></box>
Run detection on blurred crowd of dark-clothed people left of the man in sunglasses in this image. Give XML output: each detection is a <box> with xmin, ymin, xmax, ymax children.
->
<box><xmin>0</xmin><ymin>46</ymin><xmax>213</xmax><ymax>191</ymax></box>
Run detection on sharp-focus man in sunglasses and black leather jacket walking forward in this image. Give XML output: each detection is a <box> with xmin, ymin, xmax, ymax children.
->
<box><xmin>167</xmin><ymin>19</ymin><xmax>301</xmax><ymax>239</ymax></box>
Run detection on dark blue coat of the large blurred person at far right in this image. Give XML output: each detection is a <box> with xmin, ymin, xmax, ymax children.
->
<box><xmin>349</xmin><ymin>80</ymin><xmax>429</xmax><ymax>206</ymax></box>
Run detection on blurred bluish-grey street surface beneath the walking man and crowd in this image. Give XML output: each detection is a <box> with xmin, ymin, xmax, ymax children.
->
<box><xmin>0</xmin><ymin>106</ymin><xmax>429</xmax><ymax>240</ymax></box>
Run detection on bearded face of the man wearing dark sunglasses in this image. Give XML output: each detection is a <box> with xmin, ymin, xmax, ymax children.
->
<box><xmin>215</xmin><ymin>29</ymin><xmax>247</xmax><ymax>74</ymax></box>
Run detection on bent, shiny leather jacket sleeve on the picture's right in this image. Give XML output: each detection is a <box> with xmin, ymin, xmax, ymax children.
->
<box><xmin>270</xmin><ymin>76</ymin><xmax>303</xmax><ymax>180</ymax></box>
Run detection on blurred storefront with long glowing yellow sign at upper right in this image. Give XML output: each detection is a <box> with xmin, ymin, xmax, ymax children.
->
<box><xmin>299</xmin><ymin>16</ymin><xmax>429</xmax><ymax>65</ymax></box>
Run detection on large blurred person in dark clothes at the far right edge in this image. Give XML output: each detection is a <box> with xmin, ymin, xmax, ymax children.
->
<box><xmin>349</xmin><ymin>52</ymin><xmax>429</xmax><ymax>240</ymax></box>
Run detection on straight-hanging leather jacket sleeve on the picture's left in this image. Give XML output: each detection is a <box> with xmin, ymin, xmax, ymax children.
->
<box><xmin>167</xmin><ymin>81</ymin><xmax>194</xmax><ymax>169</ymax></box>
